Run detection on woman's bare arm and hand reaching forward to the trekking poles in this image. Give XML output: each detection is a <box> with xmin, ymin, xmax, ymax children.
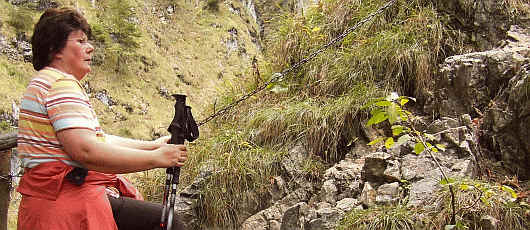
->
<box><xmin>57</xmin><ymin>129</ymin><xmax>187</xmax><ymax>173</ymax></box>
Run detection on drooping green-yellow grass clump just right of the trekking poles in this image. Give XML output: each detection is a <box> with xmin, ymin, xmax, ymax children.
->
<box><xmin>188</xmin><ymin>127</ymin><xmax>282</xmax><ymax>227</ymax></box>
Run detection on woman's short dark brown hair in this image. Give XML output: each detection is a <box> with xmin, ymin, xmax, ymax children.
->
<box><xmin>31</xmin><ymin>8</ymin><xmax>91</xmax><ymax>71</ymax></box>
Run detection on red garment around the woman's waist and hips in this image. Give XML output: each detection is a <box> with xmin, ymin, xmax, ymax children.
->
<box><xmin>17</xmin><ymin>162</ymin><xmax>143</xmax><ymax>230</ymax></box>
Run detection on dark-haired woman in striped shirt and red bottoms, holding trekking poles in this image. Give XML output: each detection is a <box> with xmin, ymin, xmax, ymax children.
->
<box><xmin>17</xmin><ymin>8</ymin><xmax>187</xmax><ymax>230</ymax></box>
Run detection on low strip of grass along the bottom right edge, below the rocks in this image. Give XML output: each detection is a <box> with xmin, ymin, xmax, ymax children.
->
<box><xmin>337</xmin><ymin>178</ymin><xmax>530</xmax><ymax>230</ymax></box>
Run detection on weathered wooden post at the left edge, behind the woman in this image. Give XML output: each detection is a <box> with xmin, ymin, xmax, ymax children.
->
<box><xmin>0</xmin><ymin>132</ymin><xmax>17</xmax><ymax>230</ymax></box>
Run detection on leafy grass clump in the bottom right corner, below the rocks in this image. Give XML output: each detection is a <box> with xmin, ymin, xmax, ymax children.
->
<box><xmin>427</xmin><ymin>179</ymin><xmax>530</xmax><ymax>230</ymax></box>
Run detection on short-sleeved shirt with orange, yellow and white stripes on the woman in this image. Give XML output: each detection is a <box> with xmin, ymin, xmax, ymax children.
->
<box><xmin>17</xmin><ymin>67</ymin><xmax>103</xmax><ymax>168</ymax></box>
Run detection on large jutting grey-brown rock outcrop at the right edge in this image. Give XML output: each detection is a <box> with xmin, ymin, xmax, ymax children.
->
<box><xmin>425</xmin><ymin>26</ymin><xmax>530</xmax><ymax>180</ymax></box>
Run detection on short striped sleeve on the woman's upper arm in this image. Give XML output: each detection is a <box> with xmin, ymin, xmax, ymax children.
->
<box><xmin>45</xmin><ymin>78</ymin><xmax>98</xmax><ymax>132</ymax></box>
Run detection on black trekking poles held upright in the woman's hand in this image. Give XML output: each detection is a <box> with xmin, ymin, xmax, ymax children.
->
<box><xmin>160</xmin><ymin>94</ymin><xmax>199</xmax><ymax>230</ymax></box>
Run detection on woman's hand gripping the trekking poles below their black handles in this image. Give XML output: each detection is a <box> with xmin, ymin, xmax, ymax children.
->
<box><xmin>155</xmin><ymin>144</ymin><xmax>188</xmax><ymax>168</ymax></box>
